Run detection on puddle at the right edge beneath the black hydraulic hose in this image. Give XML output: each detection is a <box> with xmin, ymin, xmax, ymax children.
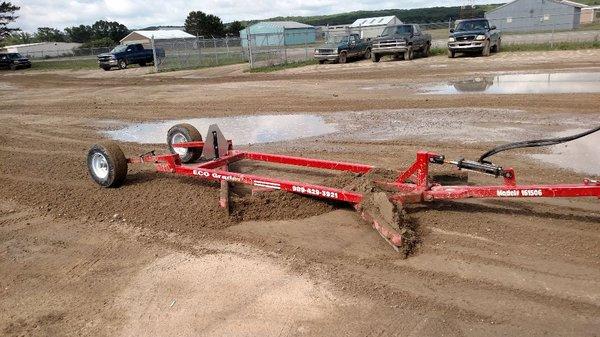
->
<box><xmin>532</xmin><ymin>130</ymin><xmax>600</xmax><ymax>175</ymax></box>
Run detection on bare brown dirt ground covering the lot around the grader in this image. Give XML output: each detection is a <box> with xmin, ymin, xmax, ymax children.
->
<box><xmin>0</xmin><ymin>50</ymin><xmax>600</xmax><ymax>336</ymax></box>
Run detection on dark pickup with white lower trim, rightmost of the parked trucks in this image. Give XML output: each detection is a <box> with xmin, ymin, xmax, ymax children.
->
<box><xmin>448</xmin><ymin>19</ymin><xmax>502</xmax><ymax>58</ymax></box>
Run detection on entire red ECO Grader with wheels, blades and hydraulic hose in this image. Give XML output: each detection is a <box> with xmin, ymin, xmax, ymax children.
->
<box><xmin>87</xmin><ymin>124</ymin><xmax>600</xmax><ymax>254</ymax></box>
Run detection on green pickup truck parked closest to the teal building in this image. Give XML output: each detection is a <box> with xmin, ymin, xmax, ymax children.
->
<box><xmin>314</xmin><ymin>34</ymin><xmax>371</xmax><ymax>64</ymax></box>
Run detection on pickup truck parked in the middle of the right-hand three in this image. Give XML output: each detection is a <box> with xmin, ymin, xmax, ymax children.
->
<box><xmin>371</xmin><ymin>24</ymin><xmax>431</xmax><ymax>62</ymax></box>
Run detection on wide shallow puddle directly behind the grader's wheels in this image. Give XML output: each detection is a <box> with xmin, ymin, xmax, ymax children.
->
<box><xmin>103</xmin><ymin>114</ymin><xmax>337</xmax><ymax>144</ymax></box>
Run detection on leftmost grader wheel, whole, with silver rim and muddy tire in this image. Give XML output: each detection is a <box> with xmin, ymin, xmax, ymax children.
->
<box><xmin>86</xmin><ymin>141</ymin><xmax>127</xmax><ymax>187</ymax></box>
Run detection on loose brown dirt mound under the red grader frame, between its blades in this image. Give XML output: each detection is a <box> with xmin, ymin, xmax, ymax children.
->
<box><xmin>231</xmin><ymin>191</ymin><xmax>342</xmax><ymax>221</ymax></box>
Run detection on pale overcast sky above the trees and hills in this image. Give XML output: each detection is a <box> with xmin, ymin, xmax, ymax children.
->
<box><xmin>11</xmin><ymin>0</ymin><xmax>496</xmax><ymax>32</ymax></box>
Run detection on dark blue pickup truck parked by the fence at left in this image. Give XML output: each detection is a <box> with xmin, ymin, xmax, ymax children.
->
<box><xmin>98</xmin><ymin>43</ymin><xmax>165</xmax><ymax>71</ymax></box>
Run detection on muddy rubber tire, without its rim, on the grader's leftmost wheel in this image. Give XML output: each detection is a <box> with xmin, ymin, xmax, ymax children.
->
<box><xmin>86</xmin><ymin>141</ymin><xmax>127</xmax><ymax>188</ymax></box>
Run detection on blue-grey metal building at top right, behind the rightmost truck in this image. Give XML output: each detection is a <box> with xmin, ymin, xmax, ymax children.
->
<box><xmin>485</xmin><ymin>0</ymin><xmax>587</xmax><ymax>32</ymax></box>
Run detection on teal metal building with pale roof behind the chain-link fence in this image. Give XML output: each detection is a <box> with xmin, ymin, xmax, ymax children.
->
<box><xmin>240</xmin><ymin>21</ymin><xmax>316</xmax><ymax>47</ymax></box>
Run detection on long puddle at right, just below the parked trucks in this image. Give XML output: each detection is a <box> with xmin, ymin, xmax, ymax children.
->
<box><xmin>425</xmin><ymin>72</ymin><xmax>600</xmax><ymax>95</ymax></box>
